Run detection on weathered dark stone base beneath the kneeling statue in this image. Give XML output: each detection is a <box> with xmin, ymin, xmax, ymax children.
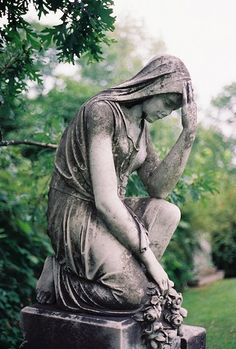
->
<box><xmin>21</xmin><ymin>305</ymin><xmax>205</xmax><ymax>349</ymax></box>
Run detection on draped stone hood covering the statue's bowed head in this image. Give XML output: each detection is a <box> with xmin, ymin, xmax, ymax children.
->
<box><xmin>99</xmin><ymin>55</ymin><xmax>191</xmax><ymax>110</ymax></box>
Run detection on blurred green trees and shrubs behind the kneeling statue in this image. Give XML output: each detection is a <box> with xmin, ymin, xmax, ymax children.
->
<box><xmin>0</xmin><ymin>1</ymin><xmax>236</xmax><ymax>349</ymax></box>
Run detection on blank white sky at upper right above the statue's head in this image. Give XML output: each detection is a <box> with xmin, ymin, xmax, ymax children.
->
<box><xmin>114</xmin><ymin>0</ymin><xmax>236</xmax><ymax>109</ymax></box>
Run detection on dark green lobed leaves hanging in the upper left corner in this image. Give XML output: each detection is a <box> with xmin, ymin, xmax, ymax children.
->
<box><xmin>0</xmin><ymin>0</ymin><xmax>115</xmax><ymax>105</ymax></box>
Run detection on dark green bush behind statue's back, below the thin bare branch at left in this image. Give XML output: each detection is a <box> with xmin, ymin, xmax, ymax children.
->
<box><xmin>0</xmin><ymin>149</ymin><xmax>51</xmax><ymax>349</ymax></box>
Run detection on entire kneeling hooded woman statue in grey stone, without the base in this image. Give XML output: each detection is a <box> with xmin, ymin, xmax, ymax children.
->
<box><xmin>36</xmin><ymin>55</ymin><xmax>197</xmax><ymax>313</ymax></box>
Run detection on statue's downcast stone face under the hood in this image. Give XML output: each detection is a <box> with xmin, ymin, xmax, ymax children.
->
<box><xmin>143</xmin><ymin>93</ymin><xmax>182</xmax><ymax>122</ymax></box>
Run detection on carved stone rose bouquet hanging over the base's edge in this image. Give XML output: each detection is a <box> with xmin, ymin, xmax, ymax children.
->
<box><xmin>133</xmin><ymin>283</ymin><xmax>187</xmax><ymax>349</ymax></box>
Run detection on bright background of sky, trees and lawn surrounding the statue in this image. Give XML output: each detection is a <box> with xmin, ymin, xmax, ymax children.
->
<box><xmin>0</xmin><ymin>0</ymin><xmax>236</xmax><ymax>349</ymax></box>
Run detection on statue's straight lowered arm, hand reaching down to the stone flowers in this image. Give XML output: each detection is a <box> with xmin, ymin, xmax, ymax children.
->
<box><xmin>87</xmin><ymin>102</ymin><xmax>171</xmax><ymax>290</ymax></box>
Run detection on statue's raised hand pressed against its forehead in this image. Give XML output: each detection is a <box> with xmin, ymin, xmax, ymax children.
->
<box><xmin>182</xmin><ymin>81</ymin><xmax>197</xmax><ymax>133</ymax></box>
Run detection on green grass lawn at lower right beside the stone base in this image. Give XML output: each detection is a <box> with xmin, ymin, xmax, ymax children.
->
<box><xmin>183</xmin><ymin>279</ymin><xmax>236</xmax><ymax>349</ymax></box>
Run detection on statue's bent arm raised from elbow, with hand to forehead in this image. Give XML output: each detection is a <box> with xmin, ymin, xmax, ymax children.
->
<box><xmin>138</xmin><ymin>83</ymin><xmax>197</xmax><ymax>199</ymax></box>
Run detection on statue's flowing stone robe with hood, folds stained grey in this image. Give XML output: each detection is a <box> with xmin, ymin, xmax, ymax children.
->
<box><xmin>45</xmin><ymin>56</ymin><xmax>190</xmax><ymax>313</ymax></box>
